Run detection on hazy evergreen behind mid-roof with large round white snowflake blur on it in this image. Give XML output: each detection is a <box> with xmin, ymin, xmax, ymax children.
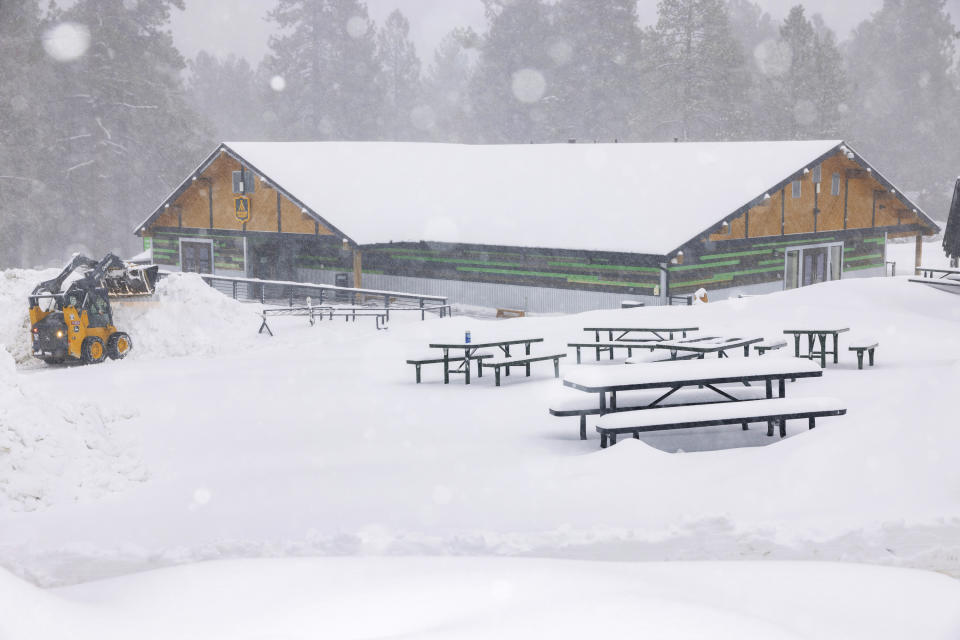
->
<box><xmin>470</xmin><ymin>0</ymin><xmax>562</xmax><ymax>143</ymax></box>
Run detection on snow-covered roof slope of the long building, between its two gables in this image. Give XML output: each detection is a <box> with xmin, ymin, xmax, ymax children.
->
<box><xmin>224</xmin><ymin>140</ymin><xmax>841</xmax><ymax>255</ymax></box>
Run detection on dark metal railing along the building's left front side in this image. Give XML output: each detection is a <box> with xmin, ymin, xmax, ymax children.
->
<box><xmin>160</xmin><ymin>271</ymin><xmax>451</xmax><ymax>319</ymax></box>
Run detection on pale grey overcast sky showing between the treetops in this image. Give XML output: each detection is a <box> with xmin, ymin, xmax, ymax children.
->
<box><xmin>167</xmin><ymin>0</ymin><xmax>960</xmax><ymax>67</ymax></box>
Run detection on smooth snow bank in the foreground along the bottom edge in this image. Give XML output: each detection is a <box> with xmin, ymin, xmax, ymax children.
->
<box><xmin>0</xmin><ymin>558</ymin><xmax>960</xmax><ymax>640</ymax></box>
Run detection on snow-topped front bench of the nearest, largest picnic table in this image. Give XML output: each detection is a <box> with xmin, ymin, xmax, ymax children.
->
<box><xmin>597</xmin><ymin>398</ymin><xmax>847</xmax><ymax>447</ymax></box>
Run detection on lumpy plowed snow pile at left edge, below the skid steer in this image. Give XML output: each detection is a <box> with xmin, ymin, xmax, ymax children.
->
<box><xmin>0</xmin><ymin>348</ymin><xmax>147</xmax><ymax>511</ymax></box>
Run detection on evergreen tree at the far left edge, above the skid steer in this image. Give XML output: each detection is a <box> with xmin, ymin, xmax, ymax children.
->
<box><xmin>0</xmin><ymin>2</ymin><xmax>62</xmax><ymax>268</ymax></box>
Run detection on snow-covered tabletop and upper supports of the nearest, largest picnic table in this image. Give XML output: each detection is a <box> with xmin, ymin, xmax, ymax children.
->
<box><xmin>563</xmin><ymin>358</ymin><xmax>823</xmax><ymax>414</ymax></box>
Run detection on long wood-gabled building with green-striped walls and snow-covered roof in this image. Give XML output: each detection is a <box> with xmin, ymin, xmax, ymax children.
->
<box><xmin>136</xmin><ymin>140</ymin><xmax>939</xmax><ymax>311</ymax></box>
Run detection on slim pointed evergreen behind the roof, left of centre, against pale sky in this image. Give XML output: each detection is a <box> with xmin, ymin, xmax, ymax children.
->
<box><xmin>377</xmin><ymin>10</ymin><xmax>422</xmax><ymax>140</ymax></box>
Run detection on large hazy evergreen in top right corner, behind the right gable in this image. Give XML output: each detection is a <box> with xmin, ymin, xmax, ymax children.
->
<box><xmin>847</xmin><ymin>0</ymin><xmax>960</xmax><ymax>217</ymax></box>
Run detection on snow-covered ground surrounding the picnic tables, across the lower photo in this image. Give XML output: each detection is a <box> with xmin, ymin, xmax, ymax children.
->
<box><xmin>0</xmin><ymin>266</ymin><xmax>960</xmax><ymax>638</ymax></box>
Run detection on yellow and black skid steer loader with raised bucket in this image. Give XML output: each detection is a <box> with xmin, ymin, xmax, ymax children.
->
<box><xmin>29</xmin><ymin>253</ymin><xmax>158</xmax><ymax>364</ymax></box>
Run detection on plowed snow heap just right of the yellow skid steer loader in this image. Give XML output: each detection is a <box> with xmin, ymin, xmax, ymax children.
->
<box><xmin>114</xmin><ymin>273</ymin><xmax>260</xmax><ymax>358</ymax></box>
